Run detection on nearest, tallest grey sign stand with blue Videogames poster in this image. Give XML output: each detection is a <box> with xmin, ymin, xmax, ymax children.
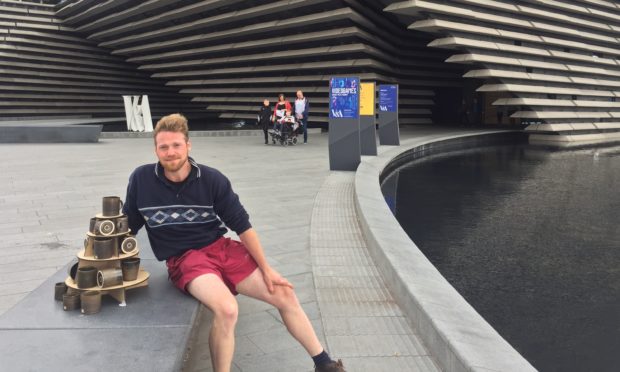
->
<box><xmin>329</xmin><ymin>77</ymin><xmax>362</xmax><ymax>170</ymax></box>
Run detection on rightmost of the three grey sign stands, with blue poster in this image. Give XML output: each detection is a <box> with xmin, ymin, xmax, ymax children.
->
<box><xmin>379</xmin><ymin>85</ymin><xmax>400</xmax><ymax>146</ymax></box>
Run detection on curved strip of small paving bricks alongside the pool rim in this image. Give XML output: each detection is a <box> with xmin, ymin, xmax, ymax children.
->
<box><xmin>310</xmin><ymin>172</ymin><xmax>439</xmax><ymax>372</ymax></box>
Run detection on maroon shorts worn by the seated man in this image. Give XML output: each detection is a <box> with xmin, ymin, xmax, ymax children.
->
<box><xmin>166</xmin><ymin>237</ymin><xmax>258</xmax><ymax>295</ymax></box>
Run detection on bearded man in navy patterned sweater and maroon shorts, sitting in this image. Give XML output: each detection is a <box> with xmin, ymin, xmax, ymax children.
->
<box><xmin>123</xmin><ymin>114</ymin><xmax>344</xmax><ymax>372</ymax></box>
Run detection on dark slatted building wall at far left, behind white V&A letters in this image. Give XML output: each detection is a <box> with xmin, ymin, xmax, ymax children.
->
<box><xmin>0</xmin><ymin>0</ymin><xmax>204</xmax><ymax>125</ymax></box>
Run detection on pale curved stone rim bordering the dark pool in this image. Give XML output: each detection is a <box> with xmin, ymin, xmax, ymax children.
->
<box><xmin>355</xmin><ymin>131</ymin><xmax>536</xmax><ymax>371</ymax></box>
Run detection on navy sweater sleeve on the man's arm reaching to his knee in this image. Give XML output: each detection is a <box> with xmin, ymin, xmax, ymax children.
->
<box><xmin>213</xmin><ymin>172</ymin><xmax>252</xmax><ymax>235</ymax></box>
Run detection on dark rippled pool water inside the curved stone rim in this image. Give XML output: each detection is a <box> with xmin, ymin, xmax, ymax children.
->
<box><xmin>382</xmin><ymin>145</ymin><xmax>620</xmax><ymax>372</ymax></box>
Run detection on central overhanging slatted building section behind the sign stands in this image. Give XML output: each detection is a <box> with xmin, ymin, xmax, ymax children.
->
<box><xmin>56</xmin><ymin>0</ymin><xmax>462</xmax><ymax>124</ymax></box>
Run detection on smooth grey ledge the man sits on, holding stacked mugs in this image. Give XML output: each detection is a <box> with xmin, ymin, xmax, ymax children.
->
<box><xmin>0</xmin><ymin>233</ymin><xmax>199</xmax><ymax>371</ymax></box>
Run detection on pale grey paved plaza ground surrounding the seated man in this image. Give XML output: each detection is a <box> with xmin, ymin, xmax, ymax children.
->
<box><xmin>0</xmin><ymin>127</ymin><xmax>456</xmax><ymax>372</ymax></box>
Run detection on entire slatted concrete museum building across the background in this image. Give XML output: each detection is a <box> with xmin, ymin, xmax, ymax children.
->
<box><xmin>0</xmin><ymin>0</ymin><xmax>620</xmax><ymax>141</ymax></box>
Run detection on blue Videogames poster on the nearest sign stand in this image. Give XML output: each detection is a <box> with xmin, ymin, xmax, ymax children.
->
<box><xmin>329</xmin><ymin>77</ymin><xmax>360</xmax><ymax>119</ymax></box>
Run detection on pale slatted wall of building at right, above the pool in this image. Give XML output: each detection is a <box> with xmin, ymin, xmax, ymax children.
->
<box><xmin>385</xmin><ymin>0</ymin><xmax>620</xmax><ymax>141</ymax></box>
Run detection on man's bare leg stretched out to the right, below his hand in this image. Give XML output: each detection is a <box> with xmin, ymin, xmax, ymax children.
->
<box><xmin>236</xmin><ymin>269</ymin><xmax>323</xmax><ymax>356</ymax></box>
